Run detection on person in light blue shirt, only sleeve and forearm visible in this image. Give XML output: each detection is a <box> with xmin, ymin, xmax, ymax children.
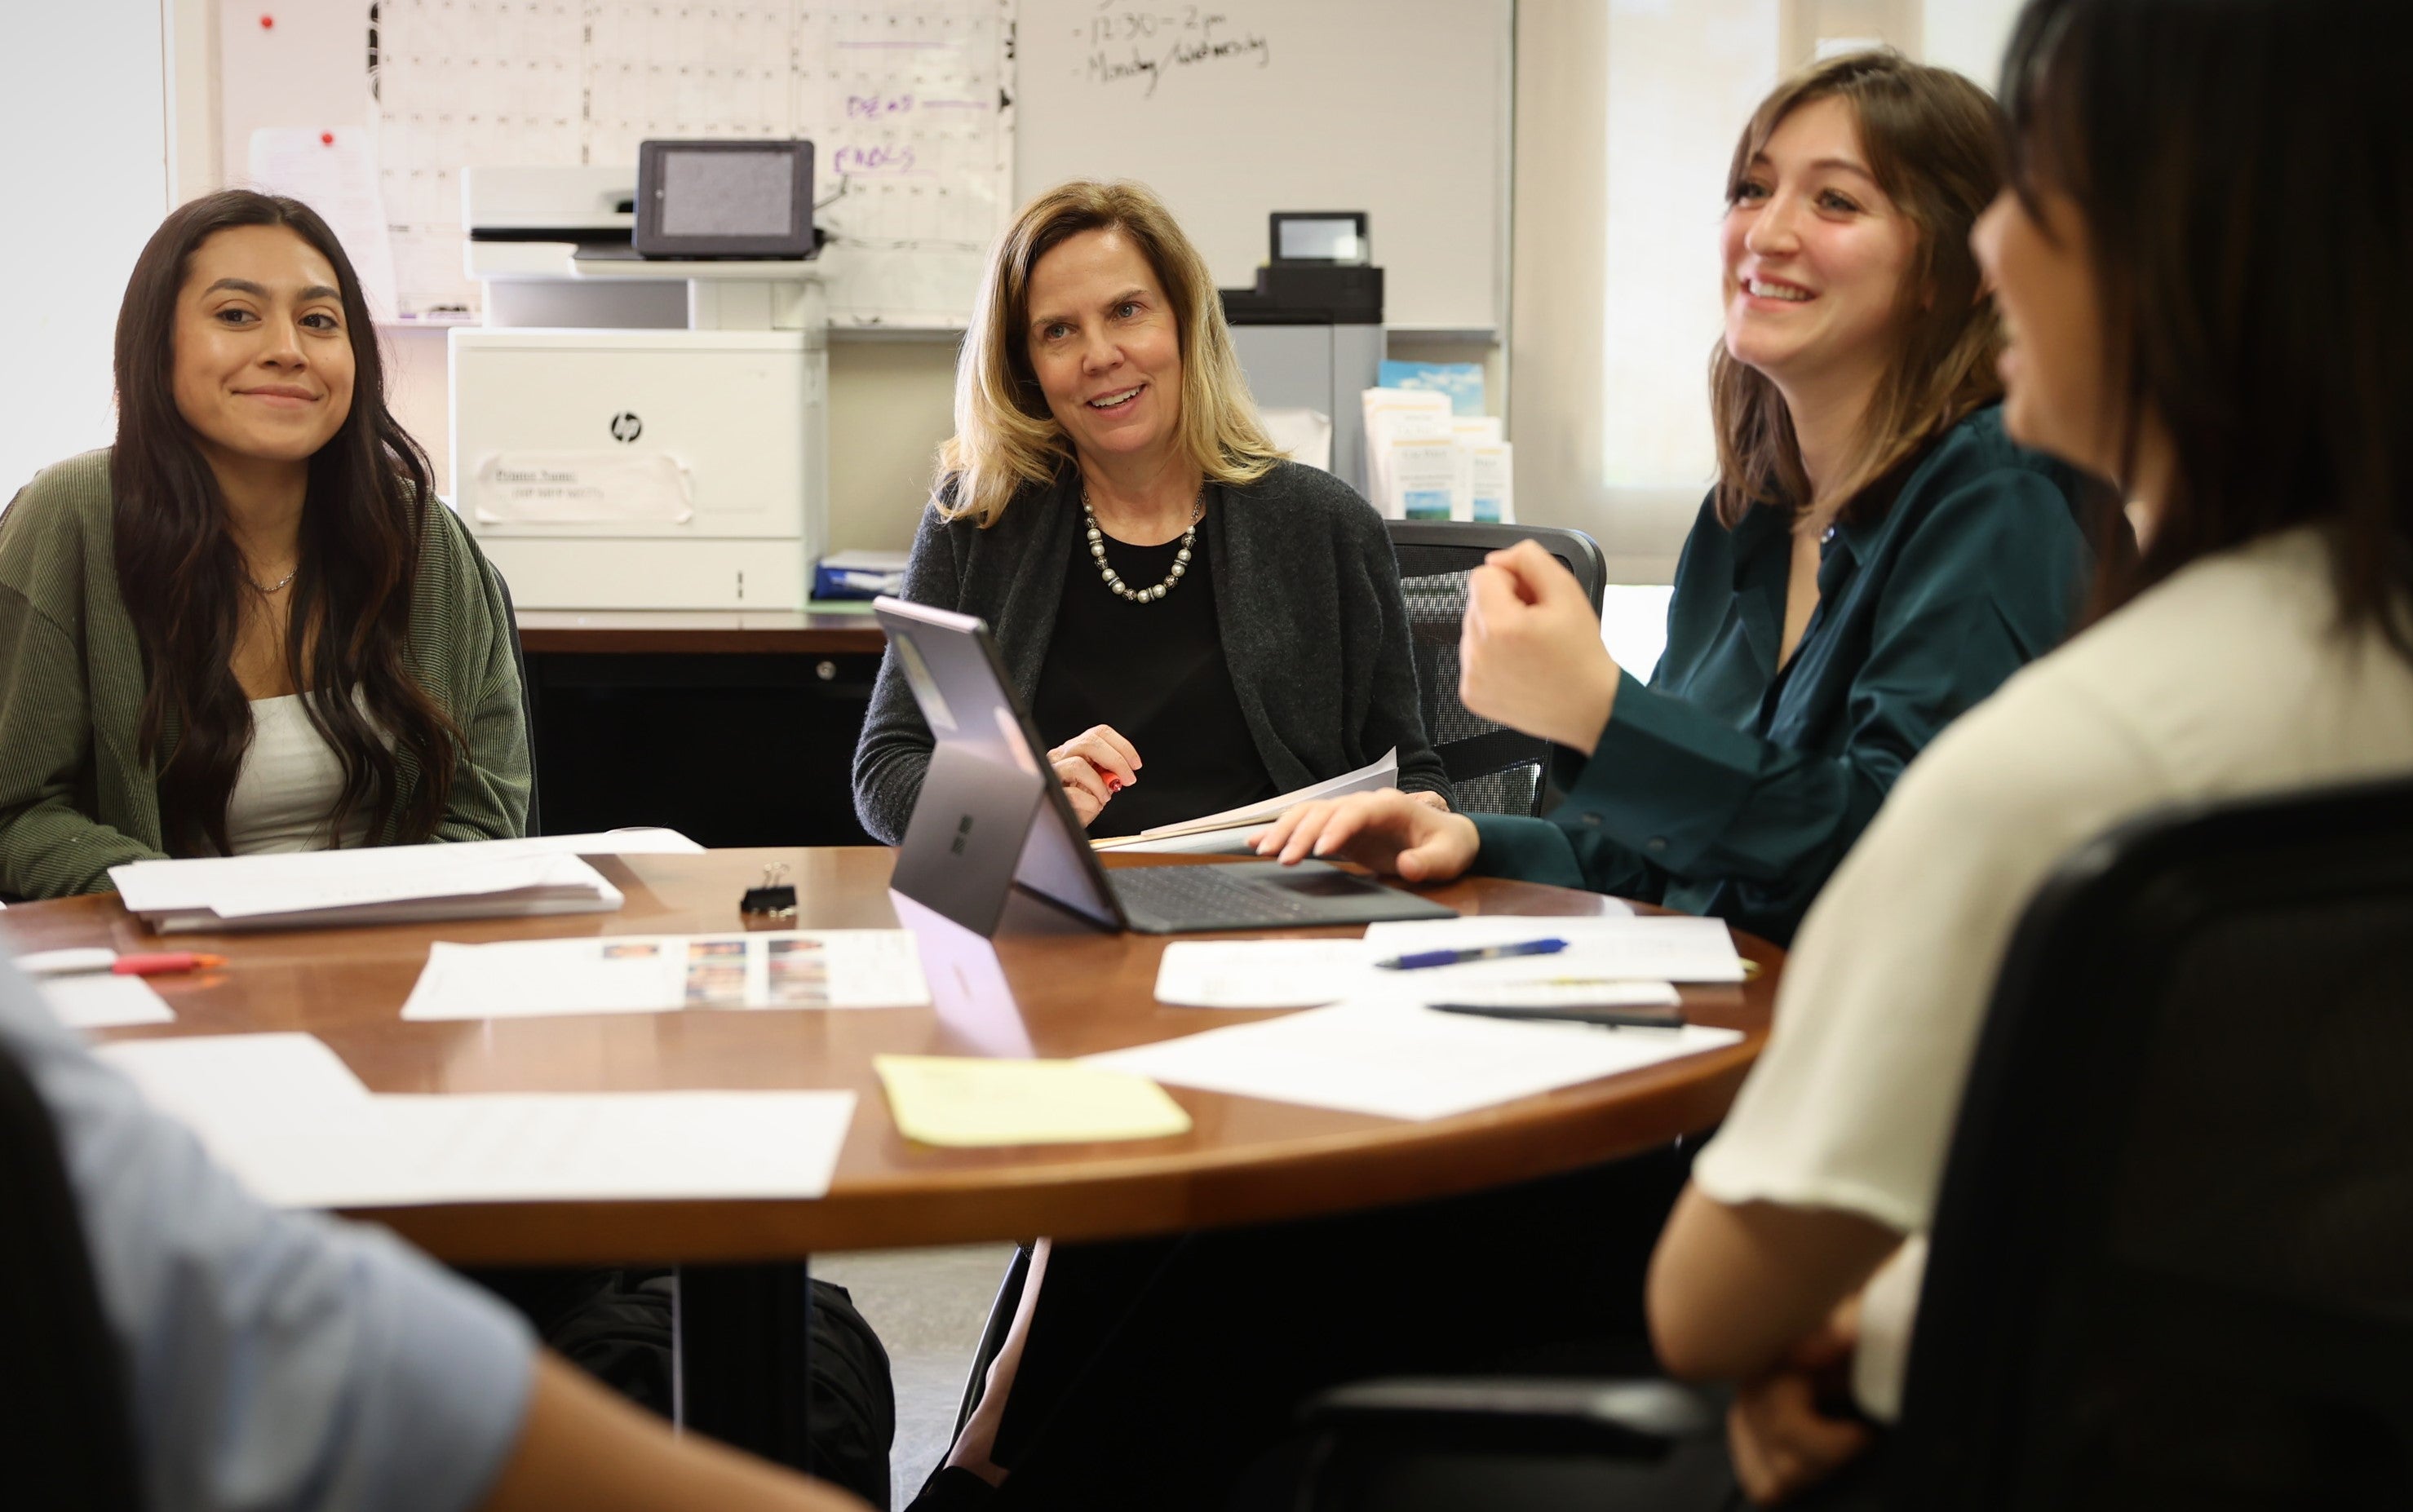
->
<box><xmin>0</xmin><ymin>960</ymin><xmax>864</xmax><ymax>1512</ymax></box>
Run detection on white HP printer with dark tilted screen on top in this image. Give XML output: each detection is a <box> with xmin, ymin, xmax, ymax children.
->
<box><xmin>449</xmin><ymin>142</ymin><xmax>830</xmax><ymax>610</ymax></box>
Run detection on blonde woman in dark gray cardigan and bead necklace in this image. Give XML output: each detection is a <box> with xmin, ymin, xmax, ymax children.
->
<box><xmin>854</xmin><ymin>181</ymin><xmax>1450</xmax><ymax>844</ymax></box>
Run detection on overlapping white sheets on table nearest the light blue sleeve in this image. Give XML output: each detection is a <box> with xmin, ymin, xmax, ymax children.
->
<box><xmin>96</xmin><ymin>1035</ymin><xmax>854</xmax><ymax>1208</ymax></box>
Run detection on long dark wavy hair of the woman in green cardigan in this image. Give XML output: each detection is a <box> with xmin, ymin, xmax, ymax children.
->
<box><xmin>108</xmin><ymin>191</ymin><xmax>461</xmax><ymax>856</ymax></box>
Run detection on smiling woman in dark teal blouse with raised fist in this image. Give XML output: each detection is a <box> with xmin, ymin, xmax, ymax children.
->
<box><xmin>1257</xmin><ymin>53</ymin><xmax>2090</xmax><ymax>943</ymax></box>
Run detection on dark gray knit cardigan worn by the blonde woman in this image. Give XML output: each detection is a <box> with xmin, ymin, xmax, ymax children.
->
<box><xmin>854</xmin><ymin>463</ymin><xmax>1450</xmax><ymax>844</ymax></box>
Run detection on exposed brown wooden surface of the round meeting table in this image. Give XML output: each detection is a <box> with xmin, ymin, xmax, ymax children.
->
<box><xmin>0</xmin><ymin>849</ymin><xmax>1783</xmax><ymax>1263</ymax></box>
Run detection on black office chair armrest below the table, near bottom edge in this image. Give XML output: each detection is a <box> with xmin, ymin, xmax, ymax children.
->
<box><xmin>1300</xmin><ymin>1377</ymin><xmax>1725</xmax><ymax>1459</ymax></box>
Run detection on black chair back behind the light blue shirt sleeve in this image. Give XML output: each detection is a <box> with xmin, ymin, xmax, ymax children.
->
<box><xmin>0</xmin><ymin>1054</ymin><xmax>143</xmax><ymax>1512</ymax></box>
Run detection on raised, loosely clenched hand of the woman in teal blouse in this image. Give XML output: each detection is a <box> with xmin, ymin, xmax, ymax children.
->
<box><xmin>1458</xmin><ymin>540</ymin><xmax>1619</xmax><ymax>755</ymax></box>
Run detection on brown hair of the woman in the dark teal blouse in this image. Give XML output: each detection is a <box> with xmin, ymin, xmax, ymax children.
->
<box><xmin>1708</xmin><ymin>51</ymin><xmax>2003</xmax><ymax>528</ymax></box>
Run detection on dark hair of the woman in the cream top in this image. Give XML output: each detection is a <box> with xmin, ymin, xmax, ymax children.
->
<box><xmin>2003</xmin><ymin>0</ymin><xmax>2413</xmax><ymax>658</ymax></box>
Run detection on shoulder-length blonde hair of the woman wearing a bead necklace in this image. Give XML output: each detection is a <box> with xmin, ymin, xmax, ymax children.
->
<box><xmin>934</xmin><ymin>179</ymin><xmax>1282</xmax><ymax>528</ymax></box>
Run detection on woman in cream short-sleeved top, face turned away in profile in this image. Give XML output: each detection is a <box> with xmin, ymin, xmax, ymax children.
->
<box><xmin>1648</xmin><ymin>0</ymin><xmax>2413</xmax><ymax>1502</ymax></box>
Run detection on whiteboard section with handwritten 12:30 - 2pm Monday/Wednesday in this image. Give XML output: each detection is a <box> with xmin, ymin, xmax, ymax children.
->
<box><xmin>1013</xmin><ymin>0</ymin><xmax>1513</xmax><ymax>330</ymax></box>
